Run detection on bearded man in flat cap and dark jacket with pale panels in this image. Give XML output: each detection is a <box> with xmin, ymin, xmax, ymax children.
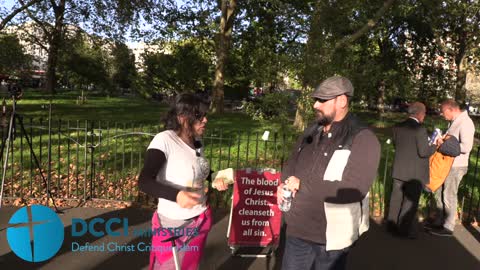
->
<box><xmin>277</xmin><ymin>76</ymin><xmax>380</xmax><ymax>270</ymax></box>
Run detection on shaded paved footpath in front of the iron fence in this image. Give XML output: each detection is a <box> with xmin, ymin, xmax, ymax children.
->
<box><xmin>0</xmin><ymin>207</ymin><xmax>480</xmax><ymax>270</ymax></box>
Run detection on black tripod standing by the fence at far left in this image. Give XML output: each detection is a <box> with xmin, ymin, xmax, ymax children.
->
<box><xmin>0</xmin><ymin>94</ymin><xmax>63</xmax><ymax>214</ymax></box>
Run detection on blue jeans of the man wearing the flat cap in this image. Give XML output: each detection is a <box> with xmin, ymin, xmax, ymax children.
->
<box><xmin>282</xmin><ymin>235</ymin><xmax>349</xmax><ymax>270</ymax></box>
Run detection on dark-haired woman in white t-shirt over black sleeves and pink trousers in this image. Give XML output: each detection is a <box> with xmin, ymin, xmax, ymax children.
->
<box><xmin>139</xmin><ymin>94</ymin><xmax>228</xmax><ymax>270</ymax></box>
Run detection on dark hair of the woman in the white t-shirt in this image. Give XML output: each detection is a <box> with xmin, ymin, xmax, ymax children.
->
<box><xmin>164</xmin><ymin>94</ymin><xmax>208</xmax><ymax>133</ymax></box>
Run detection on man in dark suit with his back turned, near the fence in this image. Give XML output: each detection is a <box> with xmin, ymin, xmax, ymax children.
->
<box><xmin>387</xmin><ymin>102</ymin><xmax>436</xmax><ymax>239</ymax></box>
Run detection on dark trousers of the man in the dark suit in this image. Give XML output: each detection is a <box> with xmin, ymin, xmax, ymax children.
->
<box><xmin>388</xmin><ymin>179</ymin><xmax>423</xmax><ymax>238</ymax></box>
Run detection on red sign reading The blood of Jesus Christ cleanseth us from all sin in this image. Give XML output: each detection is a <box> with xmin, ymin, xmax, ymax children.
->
<box><xmin>228</xmin><ymin>170</ymin><xmax>282</xmax><ymax>247</ymax></box>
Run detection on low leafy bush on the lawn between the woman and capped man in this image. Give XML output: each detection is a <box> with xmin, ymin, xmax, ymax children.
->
<box><xmin>245</xmin><ymin>92</ymin><xmax>295</xmax><ymax>121</ymax></box>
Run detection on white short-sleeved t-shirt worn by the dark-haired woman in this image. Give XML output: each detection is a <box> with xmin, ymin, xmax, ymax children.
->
<box><xmin>148</xmin><ymin>130</ymin><xmax>210</xmax><ymax>220</ymax></box>
